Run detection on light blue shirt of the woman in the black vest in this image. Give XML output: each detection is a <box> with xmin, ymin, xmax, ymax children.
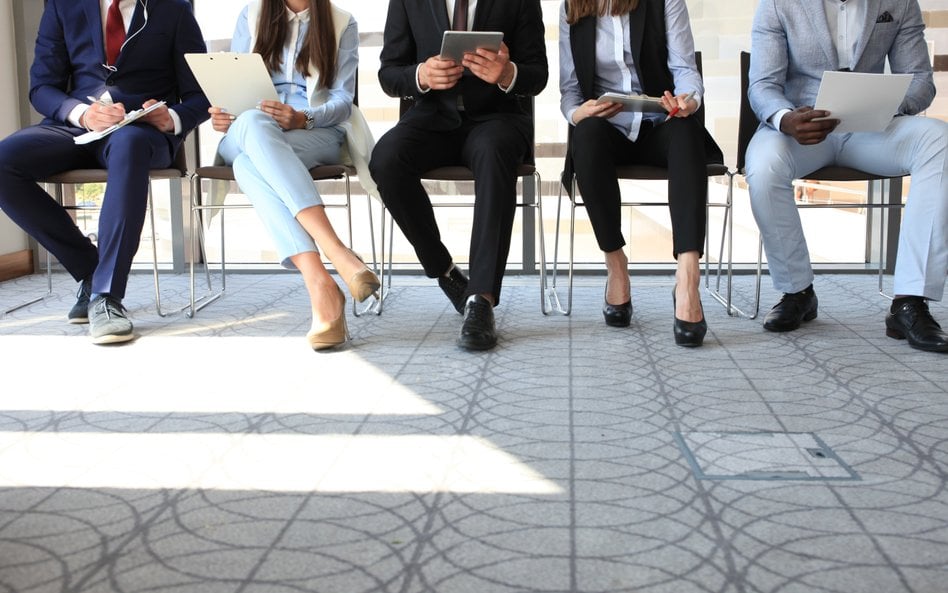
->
<box><xmin>560</xmin><ymin>0</ymin><xmax>704</xmax><ymax>140</ymax></box>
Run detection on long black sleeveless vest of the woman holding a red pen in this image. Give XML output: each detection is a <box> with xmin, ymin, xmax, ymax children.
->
<box><xmin>562</xmin><ymin>0</ymin><xmax>724</xmax><ymax>189</ymax></box>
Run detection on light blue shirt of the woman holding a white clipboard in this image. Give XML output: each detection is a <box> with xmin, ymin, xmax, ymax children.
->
<box><xmin>230</xmin><ymin>7</ymin><xmax>359</xmax><ymax>128</ymax></box>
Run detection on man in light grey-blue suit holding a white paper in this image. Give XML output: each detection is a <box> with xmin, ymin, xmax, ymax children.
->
<box><xmin>746</xmin><ymin>0</ymin><xmax>948</xmax><ymax>352</ymax></box>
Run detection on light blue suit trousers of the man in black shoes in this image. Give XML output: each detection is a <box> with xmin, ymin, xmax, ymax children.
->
<box><xmin>747</xmin><ymin>117</ymin><xmax>948</xmax><ymax>301</ymax></box>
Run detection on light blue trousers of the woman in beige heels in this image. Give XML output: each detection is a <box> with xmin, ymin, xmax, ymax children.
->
<box><xmin>217</xmin><ymin>109</ymin><xmax>345</xmax><ymax>269</ymax></box>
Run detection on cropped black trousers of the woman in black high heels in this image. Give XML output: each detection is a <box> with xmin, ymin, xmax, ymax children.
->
<box><xmin>570</xmin><ymin>117</ymin><xmax>708</xmax><ymax>258</ymax></box>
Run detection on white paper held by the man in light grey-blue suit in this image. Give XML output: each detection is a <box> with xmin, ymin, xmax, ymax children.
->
<box><xmin>814</xmin><ymin>70</ymin><xmax>912</xmax><ymax>133</ymax></box>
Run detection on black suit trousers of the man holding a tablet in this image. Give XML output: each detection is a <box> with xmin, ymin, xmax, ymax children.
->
<box><xmin>369</xmin><ymin>114</ymin><xmax>529</xmax><ymax>303</ymax></box>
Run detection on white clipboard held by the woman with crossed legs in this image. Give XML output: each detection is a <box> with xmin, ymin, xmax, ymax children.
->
<box><xmin>184</xmin><ymin>52</ymin><xmax>279</xmax><ymax>115</ymax></box>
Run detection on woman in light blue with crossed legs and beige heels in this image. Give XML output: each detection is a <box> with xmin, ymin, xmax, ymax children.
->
<box><xmin>210</xmin><ymin>0</ymin><xmax>379</xmax><ymax>350</ymax></box>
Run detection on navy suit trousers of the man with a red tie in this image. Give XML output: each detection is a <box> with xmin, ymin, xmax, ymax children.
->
<box><xmin>0</xmin><ymin>124</ymin><xmax>177</xmax><ymax>299</ymax></box>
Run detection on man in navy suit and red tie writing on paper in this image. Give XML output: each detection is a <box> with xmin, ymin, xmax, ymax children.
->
<box><xmin>0</xmin><ymin>0</ymin><xmax>210</xmax><ymax>344</ymax></box>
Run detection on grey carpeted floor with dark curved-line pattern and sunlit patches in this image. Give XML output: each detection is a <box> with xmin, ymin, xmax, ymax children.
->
<box><xmin>0</xmin><ymin>274</ymin><xmax>948</xmax><ymax>593</ymax></box>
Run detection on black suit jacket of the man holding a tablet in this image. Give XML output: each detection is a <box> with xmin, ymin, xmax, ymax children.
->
<box><xmin>379</xmin><ymin>0</ymin><xmax>549</xmax><ymax>130</ymax></box>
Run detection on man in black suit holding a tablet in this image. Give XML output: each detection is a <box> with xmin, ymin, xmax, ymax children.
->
<box><xmin>370</xmin><ymin>0</ymin><xmax>548</xmax><ymax>350</ymax></box>
